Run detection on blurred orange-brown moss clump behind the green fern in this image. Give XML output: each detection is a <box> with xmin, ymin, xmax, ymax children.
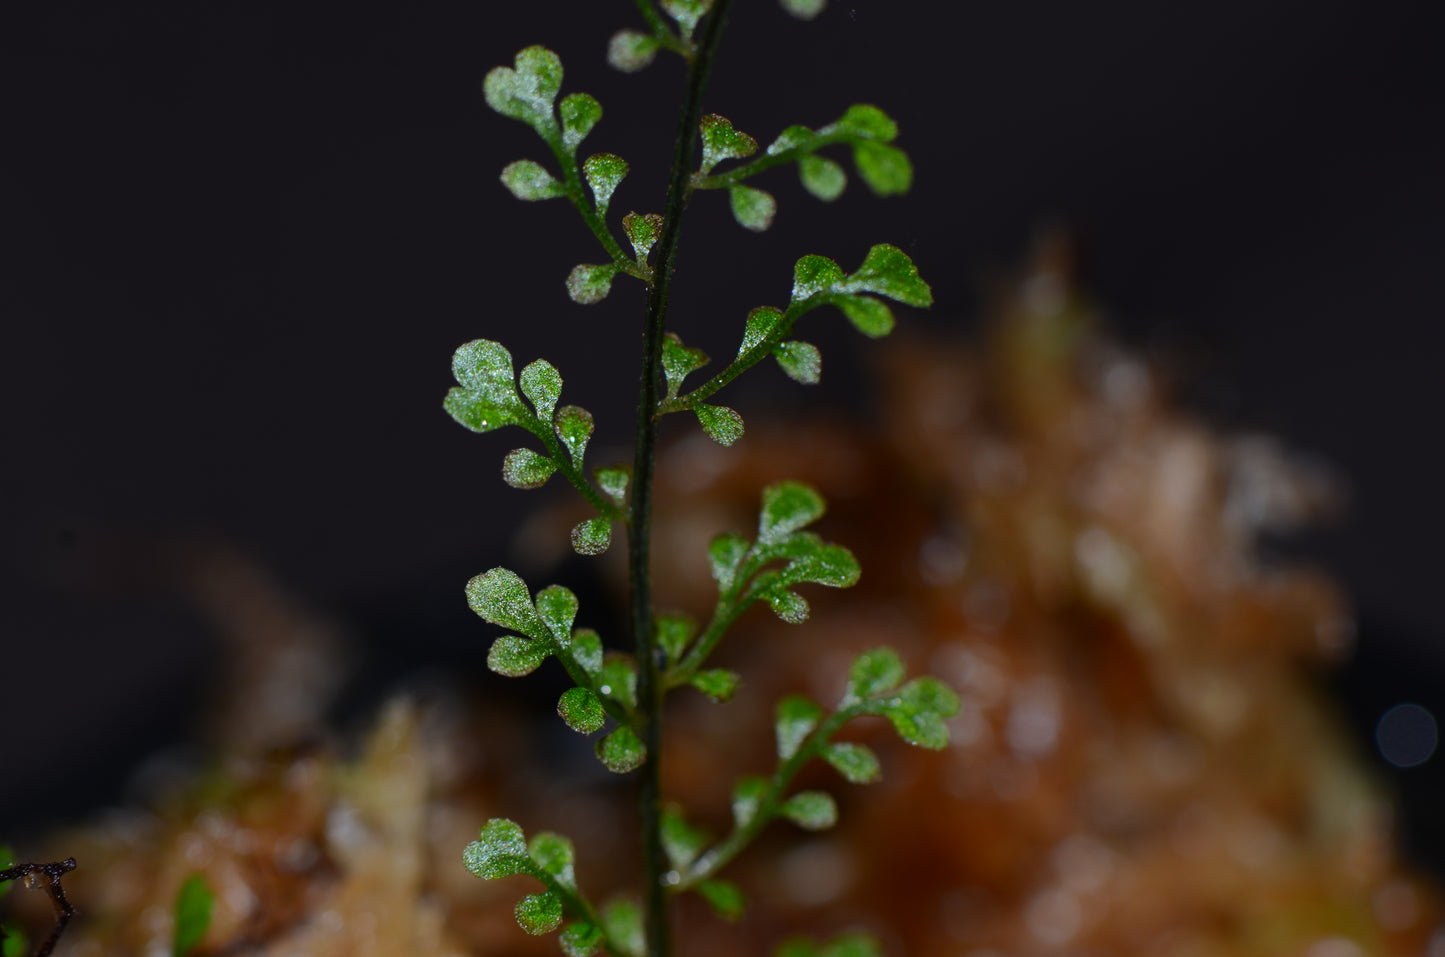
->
<box><xmin>16</xmin><ymin>250</ymin><xmax>1445</xmax><ymax>957</ymax></box>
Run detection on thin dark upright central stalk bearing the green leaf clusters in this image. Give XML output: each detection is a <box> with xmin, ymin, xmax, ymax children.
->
<box><xmin>627</xmin><ymin>0</ymin><xmax>731</xmax><ymax>957</ymax></box>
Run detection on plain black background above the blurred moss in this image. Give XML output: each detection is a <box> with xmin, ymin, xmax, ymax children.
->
<box><xmin>0</xmin><ymin>0</ymin><xmax>1445</xmax><ymax>867</ymax></box>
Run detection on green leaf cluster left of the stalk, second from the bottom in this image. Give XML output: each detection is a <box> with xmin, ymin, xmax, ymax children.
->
<box><xmin>467</xmin><ymin>568</ymin><xmax>647</xmax><ymax>773</ymax></box>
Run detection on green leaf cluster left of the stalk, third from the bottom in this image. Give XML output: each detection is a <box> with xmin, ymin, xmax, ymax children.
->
<box><xmin>442</xmin><ymin>338</ymin><xmax>629</xmax><ymax>555</ymax></box>
